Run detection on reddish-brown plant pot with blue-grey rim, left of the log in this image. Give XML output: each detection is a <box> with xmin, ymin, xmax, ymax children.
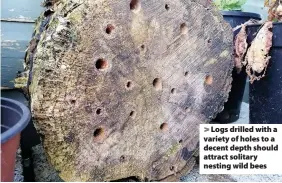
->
<box><xmin>1</xmin><ymin>97</ymin><xmax>31</xmax><ymax>182</ymax></box>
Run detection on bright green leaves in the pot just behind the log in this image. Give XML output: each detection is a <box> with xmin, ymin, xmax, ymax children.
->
<box><xmin>214</xmin><ymin>0</ymin><xmax>247</xmax><ymax>11</ymax></box>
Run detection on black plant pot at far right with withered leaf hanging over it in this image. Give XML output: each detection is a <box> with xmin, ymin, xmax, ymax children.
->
<box><xmin>247</xmin><ymin>23</ymin><xmax>282</xmax><ymax>124</ymax></box>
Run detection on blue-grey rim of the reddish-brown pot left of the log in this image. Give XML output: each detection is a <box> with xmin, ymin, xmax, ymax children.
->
<box><xmin>1</xmin><ymin>97</ymin><xmax>31</xmax><ymax>144</ymax></box>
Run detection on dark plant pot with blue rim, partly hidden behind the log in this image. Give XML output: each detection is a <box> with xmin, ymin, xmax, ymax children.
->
<box><xmin>215</xmin><ymin>11</ymin><xmax>261</xmax><ymax>123</ymax></box>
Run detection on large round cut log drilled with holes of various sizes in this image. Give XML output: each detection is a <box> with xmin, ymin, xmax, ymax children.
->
<box><xmin>22</xmin><ymin>0</ymin><xmax>233</xmax><ymax>181</ymax></box>
